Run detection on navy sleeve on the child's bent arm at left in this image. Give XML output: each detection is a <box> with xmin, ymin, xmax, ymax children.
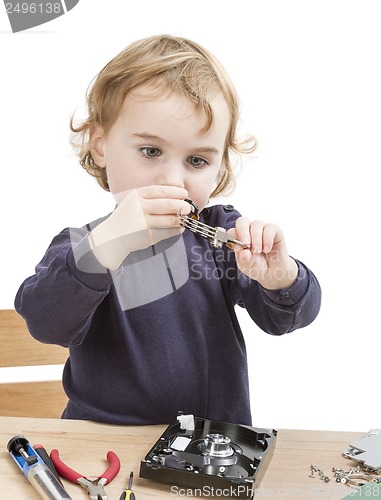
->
<box><xmin>15</xmin><ymin>228</ymin><xmax>112</xmax><ymax>347</ymax></box>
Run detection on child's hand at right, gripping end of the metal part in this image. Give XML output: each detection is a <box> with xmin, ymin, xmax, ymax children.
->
<box><xmin>228</xmin><ymin>217</ymin><xmax>298</xmax><ymax>290</ymax></box>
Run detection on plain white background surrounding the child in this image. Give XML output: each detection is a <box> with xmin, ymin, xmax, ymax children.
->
<box><xmin>0</xmin><ymin>0</ymin><xmax>381</xmax><ymax>432</ymax></box>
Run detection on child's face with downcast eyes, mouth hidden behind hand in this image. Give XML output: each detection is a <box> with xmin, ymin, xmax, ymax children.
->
<box><xmin>92</xmin><ymin>86</ymin><xmax>230</xmax><ymax>210</ymax></box>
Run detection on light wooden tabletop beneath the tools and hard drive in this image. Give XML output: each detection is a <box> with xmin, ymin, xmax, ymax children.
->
<box><xmin>0</xmin><ymin>417</ymin><xmax>367</xmax><ymax>500</ymax></box>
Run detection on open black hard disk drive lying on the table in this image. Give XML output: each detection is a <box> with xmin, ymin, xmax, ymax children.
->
<box><xmin>140</xmin><ymin>415</ymin><xmax>276</xmax><ymax>498</ymax></box>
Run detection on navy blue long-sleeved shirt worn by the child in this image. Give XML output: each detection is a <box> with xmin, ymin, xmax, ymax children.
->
<box><xmin>15</xmin><ymin>205</ymin><xmax>321</xmax><ymax>425</ymax></box>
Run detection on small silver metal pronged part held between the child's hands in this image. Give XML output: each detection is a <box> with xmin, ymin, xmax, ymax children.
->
<box><xmin>178</xmin><ymin>199</ymin><xmax>250</xmax><ymax>249</ymax></box>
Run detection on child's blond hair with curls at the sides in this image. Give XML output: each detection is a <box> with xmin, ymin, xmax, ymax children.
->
<box><xmin>70</xmin><ymin>35</ymin><xmax>256</xmax><ymax>198</ymax></box>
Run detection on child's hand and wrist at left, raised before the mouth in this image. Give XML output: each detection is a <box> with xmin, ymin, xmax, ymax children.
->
<box><xmin>89</xmin><ymin>186</ymin><xmax>191</xmax><ymax>271</ymax></box>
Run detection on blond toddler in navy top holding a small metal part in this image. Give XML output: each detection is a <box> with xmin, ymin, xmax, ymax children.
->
<box><xmin>15</xmin><ymin>36</ymin><xmax>320</xmax><ymax>425</ymax></box>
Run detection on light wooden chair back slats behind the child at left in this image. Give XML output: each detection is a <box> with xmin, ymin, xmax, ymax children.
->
<box><xmin>0</xmin><ymin>310</ymin><xmax>68</xmax><ymax>418</ymax></box>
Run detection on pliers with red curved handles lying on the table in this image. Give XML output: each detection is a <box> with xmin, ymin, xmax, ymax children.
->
<box><xmin>50</xmin><ymin>450</ymin><xmax>120</xmax><ymax>500</ymax></box>
